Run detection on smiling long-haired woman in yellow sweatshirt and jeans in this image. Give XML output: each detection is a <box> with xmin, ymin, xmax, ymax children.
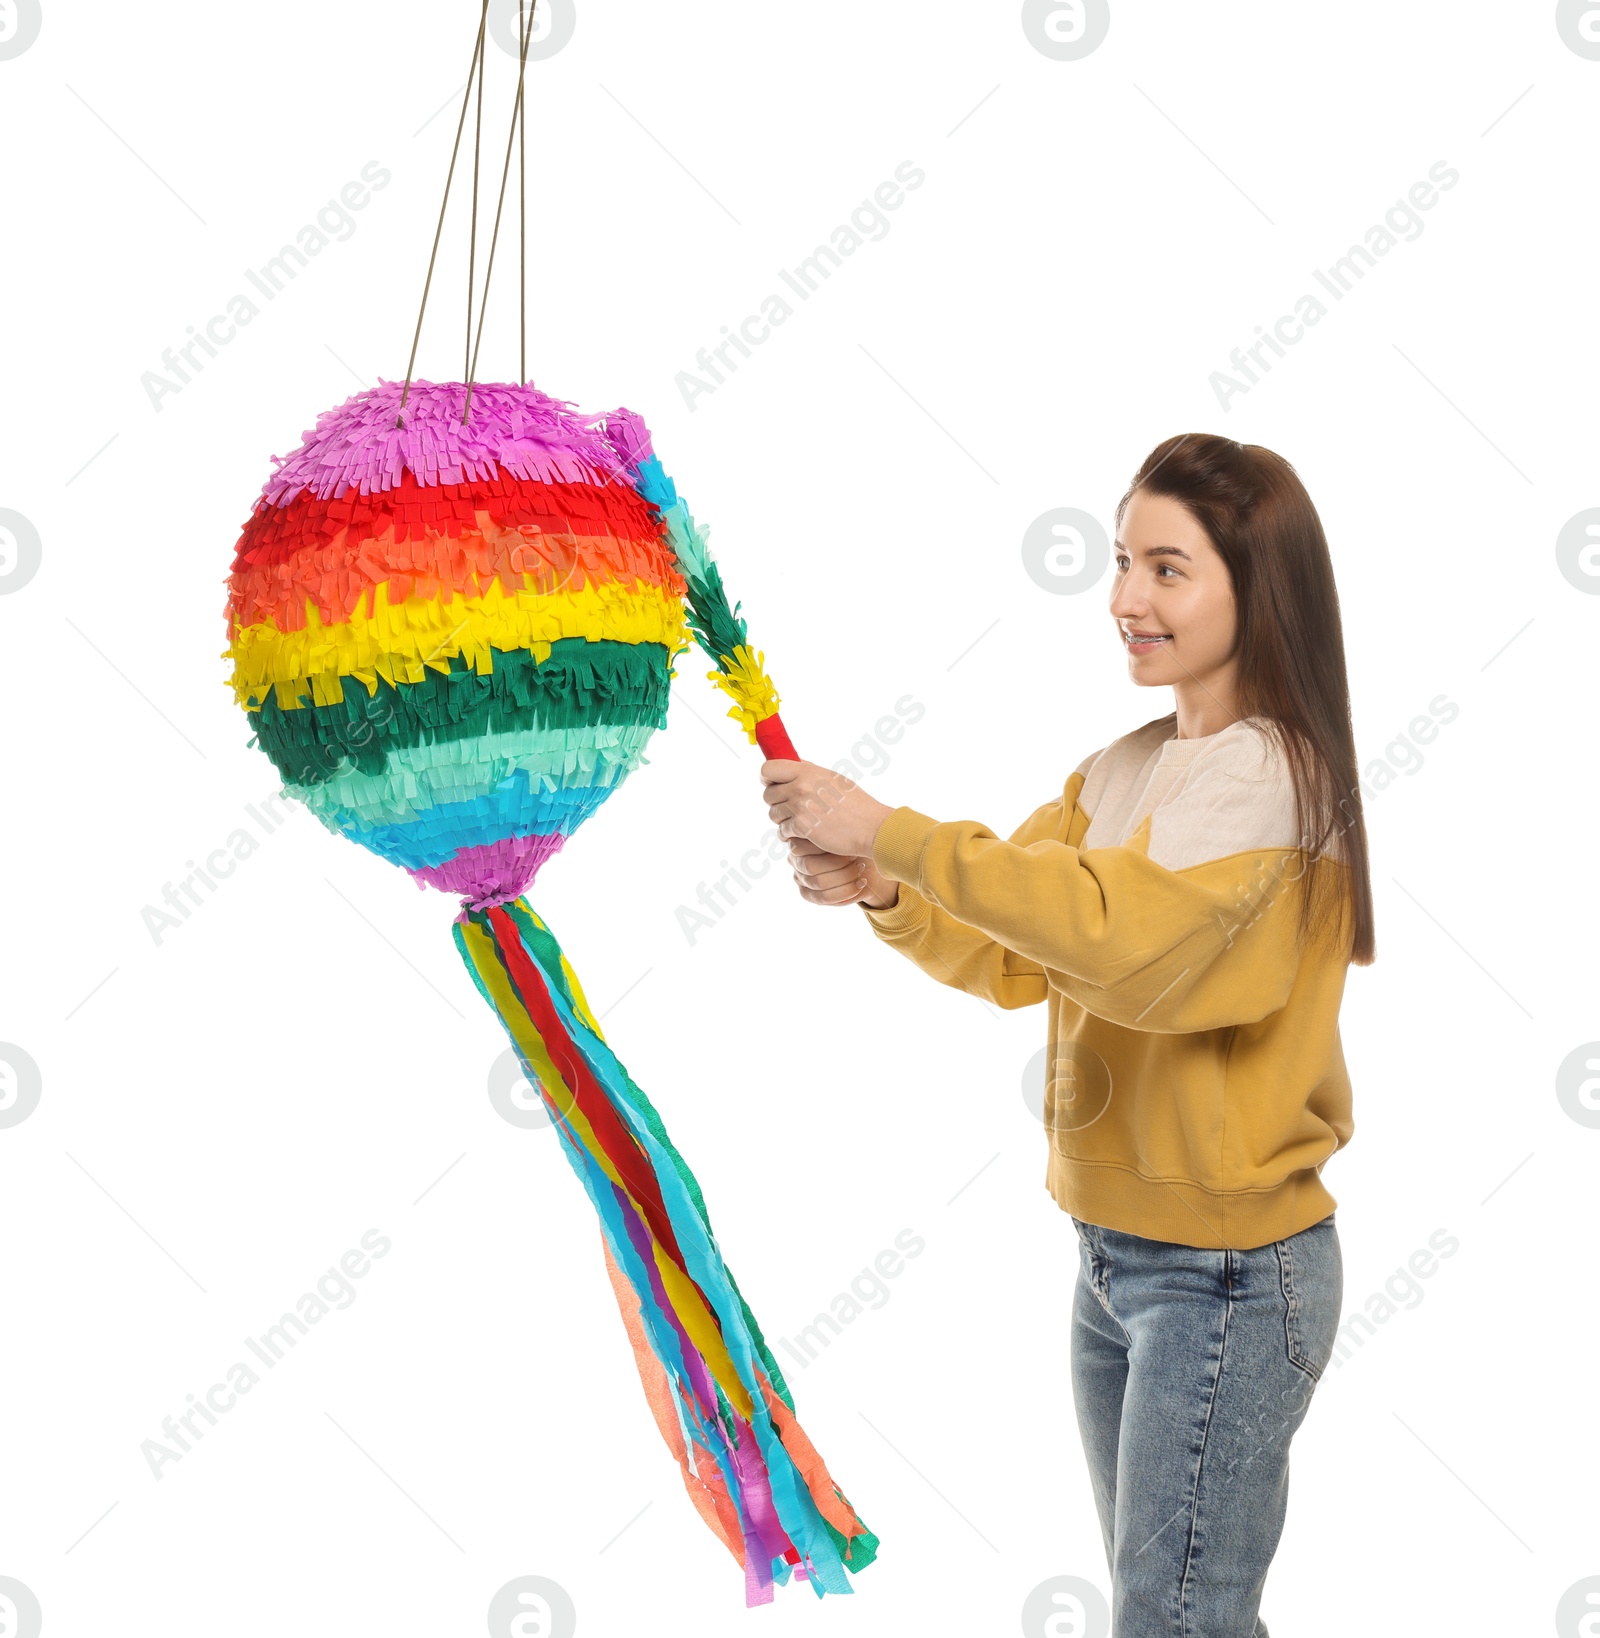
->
<box><xmin>762</xmin><ymin>432</ymin><xmax>1372</xmax><ymax>1638</ymax></box>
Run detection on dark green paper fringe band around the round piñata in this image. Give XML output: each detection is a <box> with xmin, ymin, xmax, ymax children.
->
<box><xmin>249</xmin><ymin>637</ymin><xmax>676</xmax><ymax>786</ymax></box>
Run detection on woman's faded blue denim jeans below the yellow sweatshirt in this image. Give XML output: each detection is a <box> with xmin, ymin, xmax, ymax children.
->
<box><xmin>1073</xmin><ymin>1214</ymin><xmax>1343</xmax><ymax>1638</ymax></box>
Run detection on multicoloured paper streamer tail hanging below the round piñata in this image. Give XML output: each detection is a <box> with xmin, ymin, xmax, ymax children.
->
<box><xmin>454</xmin><ymin>899</ymin><xmax>878</xmax><ymax>1605</ymax></box>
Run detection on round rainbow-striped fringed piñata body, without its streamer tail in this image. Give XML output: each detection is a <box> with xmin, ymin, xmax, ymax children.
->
<box><xmin>228</xmin><ymin>382</ymin><xmax>689</xmax><ymax>903</ymax></box>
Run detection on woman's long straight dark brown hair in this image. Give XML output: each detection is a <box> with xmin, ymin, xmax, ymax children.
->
<box><xmin>1117</xmin><ymin>432</ymin><xmax>1374</xmax><ymax>966</ymax></box>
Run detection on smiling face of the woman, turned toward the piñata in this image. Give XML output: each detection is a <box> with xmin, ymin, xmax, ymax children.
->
<box><xmin>1110</xmin><ymin>491</ymin><xmax>1236</xmax><ymax>690</ymax></box>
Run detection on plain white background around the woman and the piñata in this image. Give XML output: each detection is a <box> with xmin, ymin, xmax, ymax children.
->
<box><xmin>0</xmin><ymin>0</ymin><xmax>1600</xmax><ymax>1638</ymax></box>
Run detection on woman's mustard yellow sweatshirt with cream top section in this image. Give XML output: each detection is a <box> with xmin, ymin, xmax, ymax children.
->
<box><xmin>861</xmin><ymin>716</ymin><xmax>1353</xmax><ymax>1250</ymax></box>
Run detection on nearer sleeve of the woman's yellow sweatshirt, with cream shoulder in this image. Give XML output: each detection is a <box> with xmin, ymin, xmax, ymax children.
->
<box><xmin>873</xmin><ymin>739</ymin><xmax>1307</xmax><ymax>1034</ymax></box>
